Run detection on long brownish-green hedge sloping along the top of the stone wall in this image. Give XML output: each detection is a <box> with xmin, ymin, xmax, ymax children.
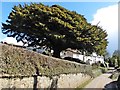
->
<box><xmin>0</xmin><ymin>44</ymin><xmax>92</xmax><ymax>76</ymax></box>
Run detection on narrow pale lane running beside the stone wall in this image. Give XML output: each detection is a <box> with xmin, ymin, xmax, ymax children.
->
<box><xmin>83</xmin><ymin>69</ymin><xmax>115</xmax><ymax>90</ymax></box>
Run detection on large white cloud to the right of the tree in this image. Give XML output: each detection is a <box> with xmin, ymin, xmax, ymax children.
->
<box><xmin>91</xmin><ymin>4</ymin><xmax>118</xmax><ymax>52</ymax></box>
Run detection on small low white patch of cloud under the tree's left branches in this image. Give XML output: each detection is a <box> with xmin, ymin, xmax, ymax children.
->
<box><xmin>2</xmin><ymin>37</ymin><xmax>23</xmax><ymax>46</ymax></box>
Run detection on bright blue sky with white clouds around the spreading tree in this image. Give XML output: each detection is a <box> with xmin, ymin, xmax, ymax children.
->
<box><xmin>0</xmin><ymin>0</ymin><xmax>118</xmax><ymax>54</ymax></box>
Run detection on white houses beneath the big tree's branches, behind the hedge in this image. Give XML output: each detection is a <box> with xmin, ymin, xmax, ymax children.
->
<box><xmin>60</xmin><ymin>48</ymin><xmax>104</xmax><ymax>65</ymax></box>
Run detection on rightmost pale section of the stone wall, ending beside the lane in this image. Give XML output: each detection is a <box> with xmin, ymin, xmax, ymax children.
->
<box><xmin>58</xmin><ymin>73</ymin><xmax>91</xmax><ymax>88</ymax></box>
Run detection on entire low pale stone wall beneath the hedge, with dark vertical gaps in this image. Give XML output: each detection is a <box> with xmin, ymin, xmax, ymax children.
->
<box><xmin>0</xmin><ymin>73</ymin><xmax>91</xmax><ymax>90</ymax></box>
